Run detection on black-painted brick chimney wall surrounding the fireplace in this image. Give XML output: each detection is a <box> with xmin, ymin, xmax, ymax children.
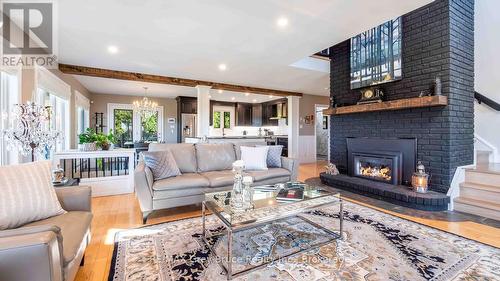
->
<box><xmin>330</xmin><ymin>0</ymin><xmax>474</xmax><ymax>193</ymax></box>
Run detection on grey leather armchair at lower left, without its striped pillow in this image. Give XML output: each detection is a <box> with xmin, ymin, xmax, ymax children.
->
<box><xmin>0</xmin><ymin>186</ymin><xmax>92</xmax><ymax>281</ymax></box>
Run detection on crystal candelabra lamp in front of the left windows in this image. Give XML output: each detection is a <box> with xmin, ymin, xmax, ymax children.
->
<box><xmin>3</xmin><ymin>102</ymin><xmax>62</xmax><ymax>161</ymax></box>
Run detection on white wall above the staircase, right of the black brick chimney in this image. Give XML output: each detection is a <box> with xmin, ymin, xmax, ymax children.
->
<box><xmin>474</xmin><ymin>0</ymin><xmax>500</xmax><ymax>159</ymax></box>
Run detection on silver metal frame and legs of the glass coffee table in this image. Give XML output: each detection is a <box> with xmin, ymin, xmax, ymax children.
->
<box><xmin>201</xmin><ymin>196</ymin><xmax>344</xmax><ymax>280</ymax></box>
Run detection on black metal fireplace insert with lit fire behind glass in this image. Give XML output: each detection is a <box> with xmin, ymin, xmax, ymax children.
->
<box><xmin>347</xmin><ymin>138</ymin><xmax>417</xmax><ymax>185</ymax></box>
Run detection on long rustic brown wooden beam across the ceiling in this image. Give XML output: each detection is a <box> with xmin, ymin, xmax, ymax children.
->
<box><xmin>59</xmin><ymin>63</ymin><xmax>302</xmax><ymax>97</ymax></box>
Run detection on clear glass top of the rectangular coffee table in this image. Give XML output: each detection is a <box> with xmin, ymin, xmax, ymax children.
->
<box><xmin>205</xmin><ymin>183</ymin><xmax>340</xmax><ymax>227</ymax></box>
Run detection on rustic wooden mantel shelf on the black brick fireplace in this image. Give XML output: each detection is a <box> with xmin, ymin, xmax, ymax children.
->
<box><xmin>323</xmin><ymin>96</ymin><xmax>448</xmax><ymax>115</ymax></box>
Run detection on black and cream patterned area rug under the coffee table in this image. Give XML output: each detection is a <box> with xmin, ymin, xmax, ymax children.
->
<box><xmin>109</xmin><ymin>202</ymin><xmax>500</xmax><ymax>281</ymax></box>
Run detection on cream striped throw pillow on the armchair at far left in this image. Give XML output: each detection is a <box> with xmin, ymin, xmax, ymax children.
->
<box><xmin>0</xmin><ymin>161</ymin><xmax>66</xmax><ymax>230</ymax></box>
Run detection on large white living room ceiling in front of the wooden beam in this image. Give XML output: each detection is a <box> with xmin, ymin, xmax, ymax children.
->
<box><xmin>58</xmin><ymin>0</ymin><xmax>431</xmax><ymax>95</ymax></box>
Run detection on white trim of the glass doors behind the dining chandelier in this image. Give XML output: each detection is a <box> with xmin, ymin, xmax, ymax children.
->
<box><xmin>106</xmin><ymin>103</ymin><xmax>164</xmax><ymax>142</ymax></box>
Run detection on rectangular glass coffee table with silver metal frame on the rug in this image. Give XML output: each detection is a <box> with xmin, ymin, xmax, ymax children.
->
<box><xmin>202</xmin><ymin>183</ymin><xmax>343</xmax><ymax>280</ymax></box>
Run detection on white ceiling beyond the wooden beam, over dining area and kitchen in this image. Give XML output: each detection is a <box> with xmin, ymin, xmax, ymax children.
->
<box><xmin>79</xmin><ymin>75</ymin><xmax>282</xmax><ymax>103</ymax></box>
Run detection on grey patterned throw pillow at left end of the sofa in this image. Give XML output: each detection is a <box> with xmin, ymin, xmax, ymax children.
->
<box><xmin>142</xmin><ymin>149</ymin><xmax>181</xmax><ymax>180</ymax></box>
